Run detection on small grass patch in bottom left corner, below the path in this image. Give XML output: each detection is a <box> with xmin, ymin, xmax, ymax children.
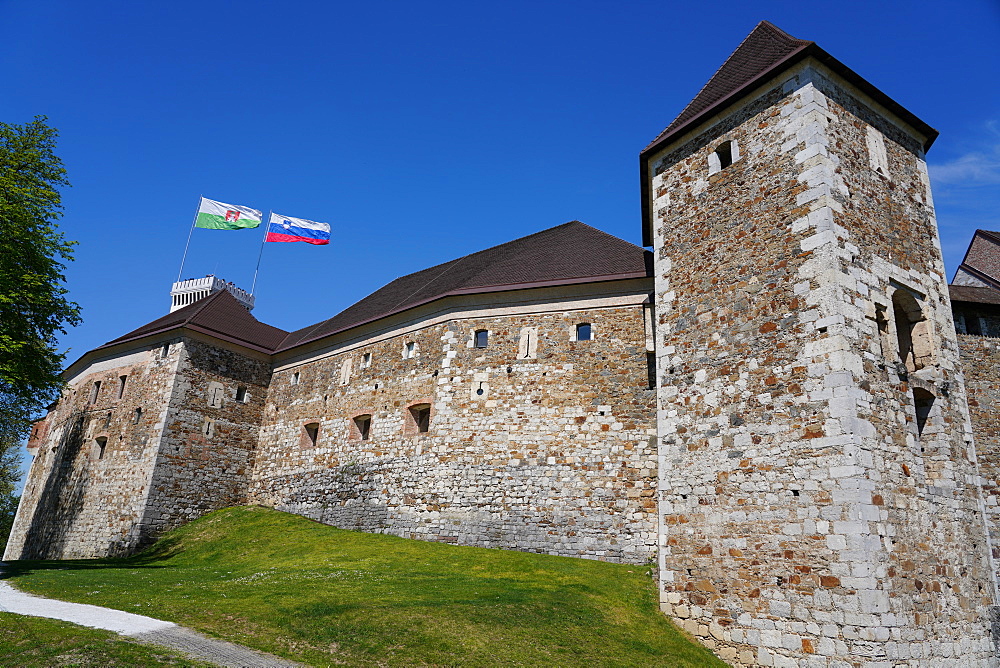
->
<box><xmin>0</xmin><ymin>612</ymin><xmax>212</xmax><ymax>668</ymax></box>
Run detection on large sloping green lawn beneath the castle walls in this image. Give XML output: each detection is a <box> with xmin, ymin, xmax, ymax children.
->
<box><xmin>0</xmin><ymin>508</ymin><xmax>725</xmax><ymax>668</ymax></box>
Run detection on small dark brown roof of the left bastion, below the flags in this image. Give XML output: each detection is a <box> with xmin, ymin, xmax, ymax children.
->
<box><xmin>97</xmin><ymin>290</ymin><xmax>288</xmax><ymax>353</ymax></box>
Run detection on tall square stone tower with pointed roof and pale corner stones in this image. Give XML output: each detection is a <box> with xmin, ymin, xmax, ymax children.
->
<box><xmin>640</xmin><ymin>22</ymin><xmax>995</xmax><ymax>668</ymax></box>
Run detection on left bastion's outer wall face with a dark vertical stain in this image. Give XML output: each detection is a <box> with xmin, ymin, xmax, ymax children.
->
<box><xmin>5</xmin><ymin>349</ymin><xmax>177</xmax><ymax>559</ymax></box>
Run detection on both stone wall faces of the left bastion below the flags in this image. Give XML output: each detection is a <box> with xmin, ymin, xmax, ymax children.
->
<box><xmin>6</xmin><ymin>337</ymin><xmax>270</xmax><ymax>559</ymax></box>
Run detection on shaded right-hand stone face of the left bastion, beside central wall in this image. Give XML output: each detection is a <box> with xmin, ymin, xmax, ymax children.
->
<box><xmin>142</xmin><ymin>337</ymin><xmax>271</xmax><ymax>537</ymax></box>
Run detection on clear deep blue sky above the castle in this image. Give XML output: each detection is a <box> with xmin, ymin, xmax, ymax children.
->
<box><xmin>0</xmin><ymin>0</ymin><xmax>1000</xmax><ymax>490</ymax></box>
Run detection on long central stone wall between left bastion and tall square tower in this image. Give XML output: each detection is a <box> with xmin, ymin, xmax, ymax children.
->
<box><xmin>250</xmin><ymin>305</ymin><xmax>656</xmax><ymax>563</ymax></box>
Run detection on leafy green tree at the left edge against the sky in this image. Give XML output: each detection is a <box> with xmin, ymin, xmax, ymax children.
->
<box><xmin>0</xmin><ymin>116</ymin><xmax>80</xmax><ymax>440</ymax></box>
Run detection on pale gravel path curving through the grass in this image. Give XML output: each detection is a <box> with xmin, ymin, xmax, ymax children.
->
<box><xmin>0</xmin><ymin>562</ymin><xmax>301</xmax><ymax>668</ymax></box>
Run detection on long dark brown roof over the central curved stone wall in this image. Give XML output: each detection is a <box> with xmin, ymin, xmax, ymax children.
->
<box><xmin>278</xmin><ymin>221</ymin><xmax>652</xmax><ymax>350</ymax></box>
